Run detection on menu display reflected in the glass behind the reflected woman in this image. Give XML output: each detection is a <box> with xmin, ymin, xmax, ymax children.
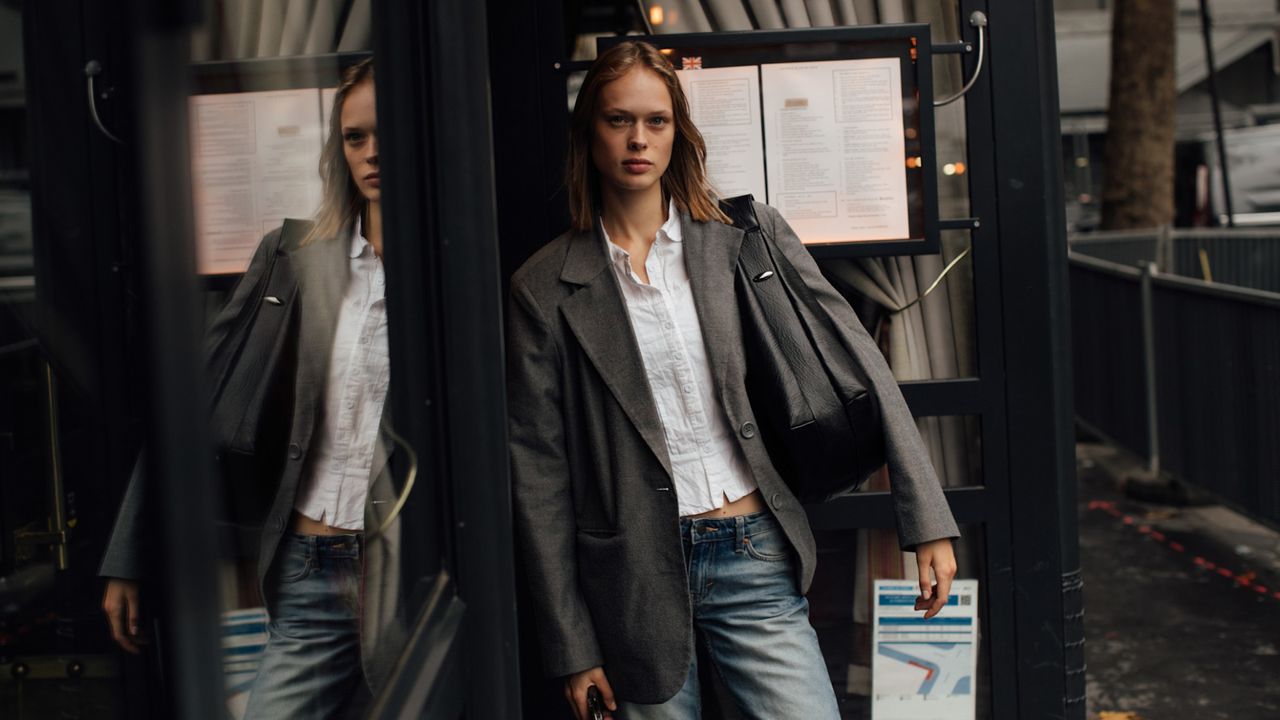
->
<box><xmin>189</xmin><ymin>54</ymin><xmax>366</xmax><ymax>275</ymax></box>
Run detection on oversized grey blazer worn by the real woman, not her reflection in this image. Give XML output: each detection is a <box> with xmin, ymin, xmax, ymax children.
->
<box><xmin>507</xmin><ymin>204</ymin><xmax>959</xmax><ymax>703</ymax></box>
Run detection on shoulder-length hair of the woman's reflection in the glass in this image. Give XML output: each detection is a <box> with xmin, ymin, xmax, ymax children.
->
<box><xmin>302</xmin><ymin>58</ymin><xmax>374</xmax><ymax>245</ymax></box>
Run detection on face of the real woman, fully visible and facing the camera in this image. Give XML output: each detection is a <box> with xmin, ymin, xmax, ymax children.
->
<box><xmin>591</xmin><ymin>68</ymin><xmax>676</xmax><ymax>202</ymax></box>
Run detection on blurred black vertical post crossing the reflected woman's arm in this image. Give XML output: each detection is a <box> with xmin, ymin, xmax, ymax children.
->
<box><xmin>131</xmin><ymin>0</ymin><xmax>225</xmax><ymax>720</ymax></box>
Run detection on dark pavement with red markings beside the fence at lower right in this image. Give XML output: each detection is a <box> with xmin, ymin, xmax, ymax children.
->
<box><xmin>1076</xmin><ymin>443</ymin><xmax>1280</xmax><ymax>720</ymax></box>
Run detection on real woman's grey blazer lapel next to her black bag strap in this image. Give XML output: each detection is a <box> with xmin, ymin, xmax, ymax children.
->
<box><xmin>680</xmin><ymin>213</ymin><xmax>744</xmax><ymax>397</ymax></box>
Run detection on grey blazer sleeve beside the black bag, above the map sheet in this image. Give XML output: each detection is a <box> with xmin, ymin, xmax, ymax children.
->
<box><xmin>755</xmin><ymin>202</ymin><xmax>960</xmax><ymax>550</ymax></box>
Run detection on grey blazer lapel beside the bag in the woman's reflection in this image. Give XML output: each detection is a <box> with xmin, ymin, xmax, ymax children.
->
<box><xmin>291</xmin><ymin>229</ymin><xmax>351</xmax><ymax>416</ymax></box>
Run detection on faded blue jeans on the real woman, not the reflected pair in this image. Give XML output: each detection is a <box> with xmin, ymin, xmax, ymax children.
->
<box><xmin>618</xmin><ymin>510</ymin><xmax>840</xmax><ymax>720</ymax></box>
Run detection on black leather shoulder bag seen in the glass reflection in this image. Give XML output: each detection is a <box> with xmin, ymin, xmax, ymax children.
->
<box><xmin>206</xmin><ymin>220</ymin><xmax>311</xmax><ymax>525</ymax></box>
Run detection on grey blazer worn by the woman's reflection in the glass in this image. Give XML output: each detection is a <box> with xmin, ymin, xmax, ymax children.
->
<box><xmin>99</xmin><ymin>229</ymin><xmax>404</xmax><ymax>689</ymax></box>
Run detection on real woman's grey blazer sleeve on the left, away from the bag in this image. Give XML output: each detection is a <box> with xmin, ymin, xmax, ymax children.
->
<box><xmin>507</xmin><ymin>274</ymin><xmax>604</xmax><ymax>676</ymax></box>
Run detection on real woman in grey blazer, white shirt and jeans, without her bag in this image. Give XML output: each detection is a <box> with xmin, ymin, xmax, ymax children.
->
<box><xmin>508</xmin><ymin>42</ymin><xmax>959</xmax><ymax>720</ymax></box>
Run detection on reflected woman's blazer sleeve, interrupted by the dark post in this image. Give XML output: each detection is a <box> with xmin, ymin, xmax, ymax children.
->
<box><xmin>97</xmin><ymin>229</ymin><xmax>280</xmax><ymax>580</ymax></box>
